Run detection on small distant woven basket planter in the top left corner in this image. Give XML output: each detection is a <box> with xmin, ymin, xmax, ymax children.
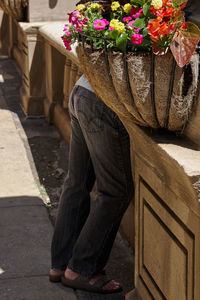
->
<box><xmin>0</xmin><ymin>0</ymin><xmax>28</xmax><ymax>20</ymax></box>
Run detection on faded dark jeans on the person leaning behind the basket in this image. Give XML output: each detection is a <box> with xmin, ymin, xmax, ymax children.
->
<box><xmin>52</xmin><ymin>86</ymin><xmax>133</xmax><ymax>276</ymax></box>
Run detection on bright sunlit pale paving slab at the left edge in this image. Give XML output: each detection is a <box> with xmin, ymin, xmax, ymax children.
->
<box><xmin>0</xmin><ymin>110</ymin><xmax>40</xmax><ymax>198</ymax></box>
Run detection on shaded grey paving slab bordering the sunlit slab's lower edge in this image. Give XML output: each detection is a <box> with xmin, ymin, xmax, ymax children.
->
<box><xmin>0</xmin><ymin>206</ymin><xmax>53</xmax><ymax>278</ymax></box>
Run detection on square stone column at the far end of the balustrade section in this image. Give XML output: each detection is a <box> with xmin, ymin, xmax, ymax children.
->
<box><xmin>13</xmin><ymin>22</ymin><xmax>45</xmax><ymax>116</ymax></box>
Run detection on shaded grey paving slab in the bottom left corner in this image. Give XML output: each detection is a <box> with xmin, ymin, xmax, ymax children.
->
<box><xmin>0</xmin><ymin>276</ymin><xmax>76</xmax><ymax>300</ymax></box>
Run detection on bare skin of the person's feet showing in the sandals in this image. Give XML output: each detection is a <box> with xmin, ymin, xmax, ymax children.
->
<box><xmin>65</xmin><ymin>268</ymin><xmax>120</xmax><ymax>291</ymax></box>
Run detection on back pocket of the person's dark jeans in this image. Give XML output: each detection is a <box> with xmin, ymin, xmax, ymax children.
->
<box><xmin>74</xmin><ymin>87</ymin><xmax>105</xmax><ymax>133</ymax></box>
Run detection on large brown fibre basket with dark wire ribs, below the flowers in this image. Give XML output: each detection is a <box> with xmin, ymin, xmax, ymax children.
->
<box><xmin>77</xmin><ymin>42</ymin><xmax>199</xmax><ymax>131</ymax></box>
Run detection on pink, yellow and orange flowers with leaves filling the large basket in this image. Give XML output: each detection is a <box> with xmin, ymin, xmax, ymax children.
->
<box><xmin>62</xmin><ymin>0</ymin><xmax>200</xmax><ymax>67</ymax></box>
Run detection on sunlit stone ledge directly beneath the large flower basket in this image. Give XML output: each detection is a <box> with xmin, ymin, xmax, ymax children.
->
<box><xmin>125</xmin><ymin>120</ymin><xmax>200</xmax><ymax>216</ymax></box>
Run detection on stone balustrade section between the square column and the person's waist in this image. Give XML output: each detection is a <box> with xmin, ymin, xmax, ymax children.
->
<box><xmin>39</xmin><ymin>24</ymin><xmax>82</xmax><ymax>141</ymax></box>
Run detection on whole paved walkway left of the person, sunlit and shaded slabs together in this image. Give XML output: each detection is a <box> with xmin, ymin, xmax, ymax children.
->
<box><xmin>0</xmin><ymin>61</ymin><xmax>77</xmax><ymax>300</ymax></box>
